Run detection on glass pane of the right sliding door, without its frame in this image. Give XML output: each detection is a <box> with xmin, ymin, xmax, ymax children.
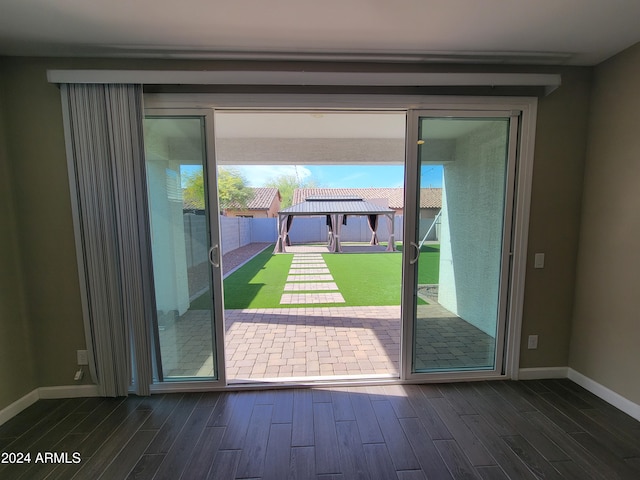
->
<box><xmin>413</xmin><ymin>118</ymin><xmax>509</xmax><ymax>372</ymax></box>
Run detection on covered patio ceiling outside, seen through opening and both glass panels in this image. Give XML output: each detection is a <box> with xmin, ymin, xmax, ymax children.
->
<box><xmin>144</xmin><ymin>111</ymin><xmax>500</xmax><ymax>165</ymax></box>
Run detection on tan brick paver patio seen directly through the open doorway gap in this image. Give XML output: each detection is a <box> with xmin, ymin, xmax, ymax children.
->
<box><xmin>225</xmin><ymin>307</ymin><xmax>400</xmax><ymax>381</ymax></box>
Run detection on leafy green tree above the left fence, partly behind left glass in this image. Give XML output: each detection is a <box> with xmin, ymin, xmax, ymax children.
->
<box><xmin>182</xmin><ymin>167</ymin><xmax>253</xmax><ymax>210</ymax></box>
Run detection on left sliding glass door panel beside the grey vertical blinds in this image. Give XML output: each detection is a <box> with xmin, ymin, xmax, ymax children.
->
<box><xmin>144</xmin><ymin>110</ymin><xmax>224</xmax><ymax>382</ymax></box>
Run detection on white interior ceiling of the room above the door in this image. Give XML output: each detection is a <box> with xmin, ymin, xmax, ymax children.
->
<box><xmin>0</xmin><ymin>0</ymin><xmax>640</xmax><ymax>65</ymax></box>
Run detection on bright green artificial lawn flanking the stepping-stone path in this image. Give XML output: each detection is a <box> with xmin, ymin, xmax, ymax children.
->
<box><xmin>190</xmin><ymin>245</ymin><xmax>440</xmax><ymax>310</ymax></box>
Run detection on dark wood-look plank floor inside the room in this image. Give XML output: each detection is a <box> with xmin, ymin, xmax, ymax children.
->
<box><xmin>0</xmin><ymin>380</ymin><xmax>640</xmax><ymax>480</ymax></box>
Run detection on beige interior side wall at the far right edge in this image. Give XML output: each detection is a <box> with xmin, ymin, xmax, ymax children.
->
<box><xmin>569</xmin><ymin>44</ymin><xmax>640</xmax><ymax>403</ymax></box>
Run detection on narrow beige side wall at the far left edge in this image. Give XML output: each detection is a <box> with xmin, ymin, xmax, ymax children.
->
<box><xmin>0</xmin><ymin>64</ymin><xmax>38</xmax><ymax>410</ymax></box>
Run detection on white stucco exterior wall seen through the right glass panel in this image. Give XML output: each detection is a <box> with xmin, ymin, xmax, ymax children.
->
<box><xmin>438</xmin><ymin>120</ymin><xmax>508</xmax><ymax>337</ymax></box>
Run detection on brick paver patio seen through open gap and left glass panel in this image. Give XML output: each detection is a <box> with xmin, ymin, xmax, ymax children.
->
<box><xmin>160</xmin><ymin>306</ymin><xmax>400</xmax><ymax>381</ymax></box>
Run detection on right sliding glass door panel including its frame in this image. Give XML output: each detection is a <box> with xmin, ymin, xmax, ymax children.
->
<box><xmin>404</xmin><ymin>112</ymin><xmax>518</xmax><ymax>378</ymax></box>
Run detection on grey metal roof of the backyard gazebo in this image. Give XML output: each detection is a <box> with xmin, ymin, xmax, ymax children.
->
<box><xmin>278</xmin><ymin>195</ymin><xmax>395</xmax><ymax>215</ymax></box>
